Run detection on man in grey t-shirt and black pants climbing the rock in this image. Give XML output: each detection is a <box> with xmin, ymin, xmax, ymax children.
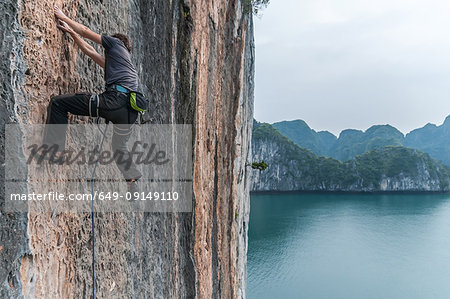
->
<box><xmin>44</xmin><ymin>5</ymin><xmax>141</xmax><ymax>189</ymax></box>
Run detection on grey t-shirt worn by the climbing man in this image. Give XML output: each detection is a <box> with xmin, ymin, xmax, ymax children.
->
<box><xmin>102</xmin><ymin>35</ymin><xmax>138</xmax><ymax>90</ymax></box>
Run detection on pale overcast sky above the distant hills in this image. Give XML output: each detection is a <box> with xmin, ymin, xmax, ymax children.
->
<box><xmin>254</xmin><ymin>0</ymin><xmax>450</xmax><ymax>135</ymax></box>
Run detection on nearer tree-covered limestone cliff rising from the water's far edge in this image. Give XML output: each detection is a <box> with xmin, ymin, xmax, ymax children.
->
<box><xmin>251</xmin><ymin>124</ymin><xmax>450</xmax><ymax>192</ymax></box>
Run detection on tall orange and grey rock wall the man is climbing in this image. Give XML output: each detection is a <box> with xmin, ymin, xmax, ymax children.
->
<box><xmin>0</xmin><ymin>0</ymin><xmax>254</xmax><ymax>298</ymax></box>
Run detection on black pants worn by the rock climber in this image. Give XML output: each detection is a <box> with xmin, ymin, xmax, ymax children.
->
<box><xmin>44</xmin><ymin>91</ymin><xmax>141</xmax><ymax>180</ymax></box>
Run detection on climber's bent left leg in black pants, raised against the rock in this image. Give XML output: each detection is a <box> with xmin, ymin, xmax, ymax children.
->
<box><xmin>43</xmin><ymin>93</ymin><xmax>91</xmax><ymax>152</ymax></box>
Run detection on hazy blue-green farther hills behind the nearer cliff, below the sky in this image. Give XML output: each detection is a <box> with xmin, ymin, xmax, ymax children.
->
<box><xmin>272</xmin><ymin>116</ymin><xmax>450</xmax><ymax>165</ymax></box>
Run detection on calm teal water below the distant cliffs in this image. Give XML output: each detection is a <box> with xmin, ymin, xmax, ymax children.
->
<box><xmin>247</xmin><ymin>194</ymin><xmax>450</xmax><ymax>299</ymax></box>
